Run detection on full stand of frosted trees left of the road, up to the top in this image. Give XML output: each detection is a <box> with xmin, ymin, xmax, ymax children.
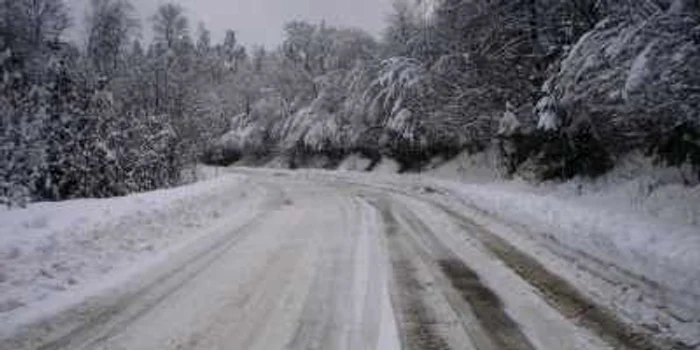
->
<box><xmin>0</xmin><ymin>0</ymin><xmax>226</xmax><ymax>205</ymax></box>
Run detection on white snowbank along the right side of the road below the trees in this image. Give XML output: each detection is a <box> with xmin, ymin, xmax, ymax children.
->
<box><xmin>288</xmin><ymin>154</ymin><xmax>700</xmax><ymax>316</ymax></box>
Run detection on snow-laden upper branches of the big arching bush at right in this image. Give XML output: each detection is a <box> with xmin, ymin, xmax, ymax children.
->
<box><xmin>553</xmin><ymin>7</ymin><xmax>700</xmax><ymax>153</ymax></box>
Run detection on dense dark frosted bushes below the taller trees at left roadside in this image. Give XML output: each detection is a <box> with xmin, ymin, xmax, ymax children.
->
<box><xmin>0</xmin><ymin>43</ymin><xmax>182</xmax><ymax>205</ymax></box>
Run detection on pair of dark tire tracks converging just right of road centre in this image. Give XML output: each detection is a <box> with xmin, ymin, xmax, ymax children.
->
<box><xmin>374</xmin><ymin>200</ymin><xmax>534</xmax><ymax>350</ymax></box>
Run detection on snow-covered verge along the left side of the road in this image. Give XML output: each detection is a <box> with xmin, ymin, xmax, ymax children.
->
<box><xmin>0</xmin><ymin>175</ymin><xmax>264</xmax><ymax>323</ymax></box>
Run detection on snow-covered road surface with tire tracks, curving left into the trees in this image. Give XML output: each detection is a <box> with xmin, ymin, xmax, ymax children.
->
<box><xmin>0</xmin><ymin>170</ymin><xmax>696</xmax><ymax>350</ymax></box>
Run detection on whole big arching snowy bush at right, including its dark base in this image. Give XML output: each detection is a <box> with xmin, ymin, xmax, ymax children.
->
<box><xmin>526</xmin><ymin>1</ymin><xmax>700</xmax><ymax>178</ymax></box>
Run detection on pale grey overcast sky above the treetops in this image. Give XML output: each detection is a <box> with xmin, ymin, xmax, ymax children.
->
<box><xmin>66</xmin><ymin>0</ymin><xmax>391</xmax><ymax>48</ymax></box>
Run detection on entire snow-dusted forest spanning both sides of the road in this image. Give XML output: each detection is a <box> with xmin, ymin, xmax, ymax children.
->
<box><xmin>0</xmin><ymin>0</ymin><xmax>700</xmax><ymax>206</ymax></box>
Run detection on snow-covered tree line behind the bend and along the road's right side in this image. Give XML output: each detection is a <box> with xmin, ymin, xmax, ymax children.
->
<box><xmin>213</xmin><ymin>0</ymin><xmax>700</xmax><ymax>181</ymax></box>
